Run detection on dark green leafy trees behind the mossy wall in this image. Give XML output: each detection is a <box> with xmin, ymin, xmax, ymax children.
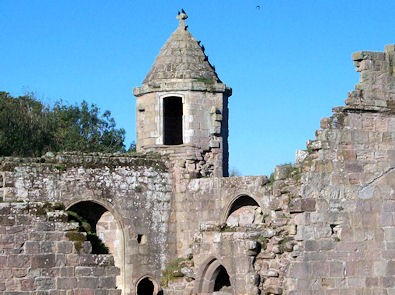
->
<box><xmin>0</xmin><ymin>92</ymin><xmax>125</xmax><ymax>156</ymax></box>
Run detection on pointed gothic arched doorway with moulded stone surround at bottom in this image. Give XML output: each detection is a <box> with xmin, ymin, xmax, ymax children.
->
<box><xmin>195</xmin><ymin>258</ymin><xmax>233</xmax><ymax>294</ymax></box>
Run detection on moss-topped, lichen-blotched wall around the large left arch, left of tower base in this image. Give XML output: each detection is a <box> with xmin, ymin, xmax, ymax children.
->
<box><xmin>0</xmin><ymin>153</ymin><xmax>175</xmax><ymax>294</ymax></box>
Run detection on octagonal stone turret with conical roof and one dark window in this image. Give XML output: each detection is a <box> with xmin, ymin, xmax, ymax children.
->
<box><xmin>133</xmin><ymin>13</ymin><xmax>232</xmax><ymax>177</ymax></box>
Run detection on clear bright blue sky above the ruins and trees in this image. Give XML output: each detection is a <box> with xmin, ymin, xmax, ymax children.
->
<box><xmin>0</xmin><ymin>0</ymin><xmax>395</xmax><ymax>175</ymax></box>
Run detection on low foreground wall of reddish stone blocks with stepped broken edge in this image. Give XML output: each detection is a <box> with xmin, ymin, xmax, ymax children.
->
<box><xmin>0</xmin><ymin>202</ymin><xmax>121</xmax><ymax>295</ymax></box>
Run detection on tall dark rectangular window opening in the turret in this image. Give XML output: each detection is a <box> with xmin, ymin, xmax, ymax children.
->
<box><xmin>163</xmin><ymin>96</ymin><xmax>183</xmax><ymax>145</ymax></box>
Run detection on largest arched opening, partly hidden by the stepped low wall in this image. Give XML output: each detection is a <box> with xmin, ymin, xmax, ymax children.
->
<box><xmin>67</xmin><ymin>201</ymin><xmax>125</xmax><ymax>290</ymax></box>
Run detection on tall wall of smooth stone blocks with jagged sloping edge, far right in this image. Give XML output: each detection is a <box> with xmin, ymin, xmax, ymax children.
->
<box><xmin>286</xmin><ymin>45</ymin><xmax>395</xmax><ymax>294</ymax></box>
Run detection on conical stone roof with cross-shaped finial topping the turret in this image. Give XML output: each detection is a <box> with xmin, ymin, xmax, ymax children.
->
<box><xmin>143</xmin><ymin>13</ymin><xmax>221</xmax><ymax>85</ymax></box>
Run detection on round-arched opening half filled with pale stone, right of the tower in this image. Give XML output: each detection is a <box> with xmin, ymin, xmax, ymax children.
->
<box><xmin>226</xmin><ymin>195</ymin><xmax>264</xmax><ymax>227</ymax></box>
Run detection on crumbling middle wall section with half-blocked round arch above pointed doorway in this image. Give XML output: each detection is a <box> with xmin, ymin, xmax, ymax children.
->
<box><xmin>165</xmin><ymin>171</ymin><xmax>315</xmax><ymax>295</ymax></box>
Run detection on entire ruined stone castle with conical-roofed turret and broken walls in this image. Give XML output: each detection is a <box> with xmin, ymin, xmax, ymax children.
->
<box><xmin>0</xmin><ymin>13</ymin><xmax>395</xmax><ymax>295</ymax></box>
